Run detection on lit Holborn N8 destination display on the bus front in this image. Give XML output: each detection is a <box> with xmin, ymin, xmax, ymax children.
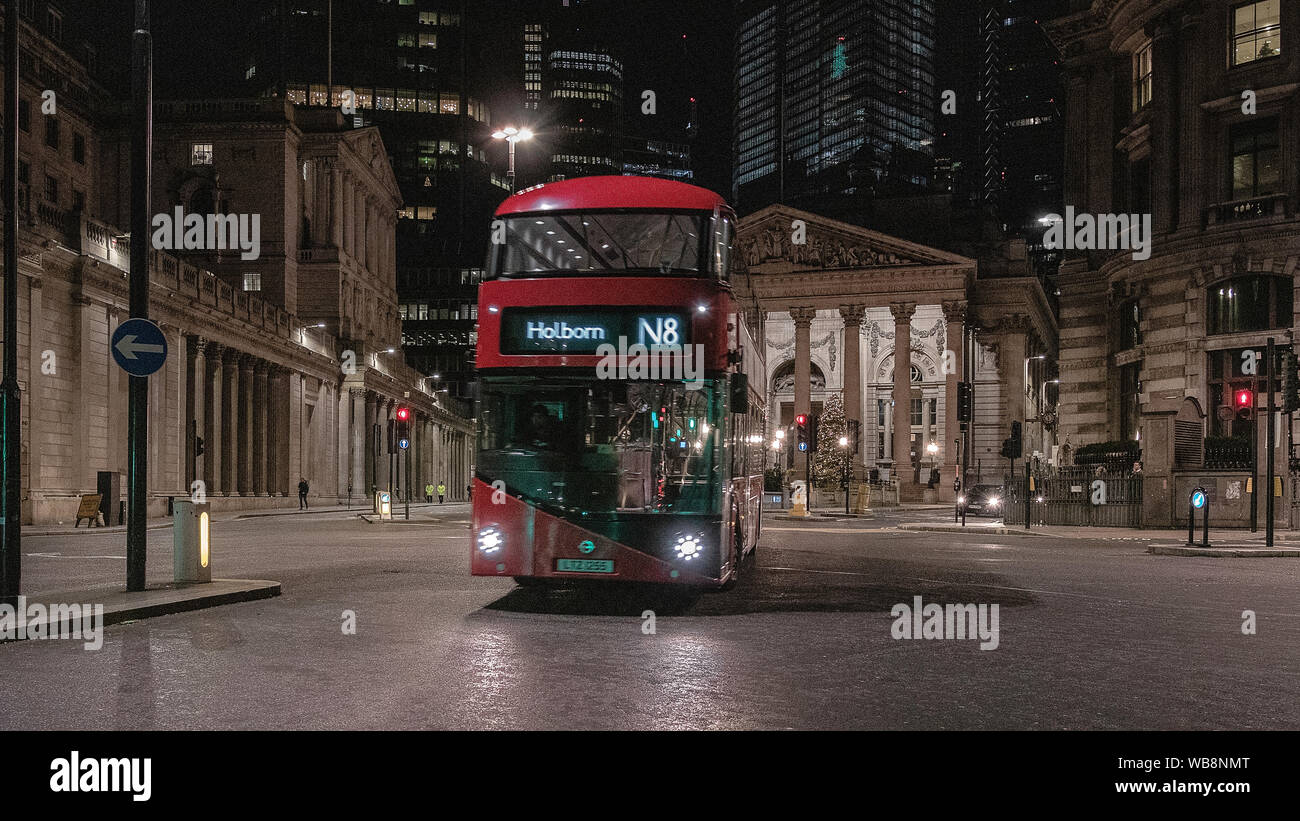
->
<box><xmin>501</xmin><ymin>308</ymin><xmax>690</xmax><ymax>355</ymax></box>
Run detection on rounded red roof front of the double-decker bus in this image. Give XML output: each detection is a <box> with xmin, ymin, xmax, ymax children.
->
<box><xmin>497</xmin><ymin>175</ymin><xmax>727</xmax><ymax>217</ymax></box>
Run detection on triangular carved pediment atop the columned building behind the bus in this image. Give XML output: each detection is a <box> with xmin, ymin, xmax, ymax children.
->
<box><xmin>736</xmin><ymin>205</ymin><xmax>975</xmax><ymax>275</ymax></box>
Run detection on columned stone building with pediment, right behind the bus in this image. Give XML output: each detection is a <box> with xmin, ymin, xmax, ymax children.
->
<box><xmin>737</xmin><ymin>205</ymin><xmax>1056</xmax><ymax>499</ymax></box>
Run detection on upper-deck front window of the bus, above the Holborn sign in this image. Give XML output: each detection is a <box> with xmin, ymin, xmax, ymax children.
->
<box><xmin>488</xmin><ymin>210</ymin><xmax>712</xmax><ymax>277</ymax></box>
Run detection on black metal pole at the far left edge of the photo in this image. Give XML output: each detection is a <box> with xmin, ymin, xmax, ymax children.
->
<box><xmin>0</xmin><ymin>0</ymin><xmax>22</xmax><ymax>604</ymax></box>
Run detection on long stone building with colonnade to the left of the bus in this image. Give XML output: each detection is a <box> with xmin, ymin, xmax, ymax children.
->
<box><xmin>4</xmin><ymin>22</ymin><xmax>473</xmax><ymax>522</ymax></box>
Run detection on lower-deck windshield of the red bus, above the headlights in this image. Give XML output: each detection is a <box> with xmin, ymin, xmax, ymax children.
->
<box><xmin>476</xmin><ymin>374</ymin><xmax>723</xmax><ymax>516</ymax></box>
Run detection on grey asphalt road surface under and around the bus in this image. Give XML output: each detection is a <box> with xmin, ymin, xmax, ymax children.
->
<box><xmin>0</xmin><ymin>505</ymin><xmax>1300</xmax><ymax>730</ymax></box>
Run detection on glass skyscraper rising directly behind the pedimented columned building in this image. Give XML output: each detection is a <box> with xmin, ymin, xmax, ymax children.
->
<box><xmin>732</xmin><ymin>0</ymin><xmax>937</xmax><ymax>212</ymax></box>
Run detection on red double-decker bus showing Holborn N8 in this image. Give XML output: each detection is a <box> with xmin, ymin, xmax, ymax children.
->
<box><xmin>471</xmin><ymin>177</ymin><xmax>766</xmax><ymax>587</ymax></box>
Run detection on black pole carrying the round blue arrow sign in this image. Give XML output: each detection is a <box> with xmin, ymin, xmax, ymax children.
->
<box><xmin>126</xmin><ymin>0</ymin><xmax>153</xmax><ymax>591</ymax></box>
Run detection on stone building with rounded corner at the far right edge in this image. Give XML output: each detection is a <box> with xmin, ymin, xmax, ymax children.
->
<box><xmin>1048</xmin><ymin>0</ymin><xmax>1300</xmax><ymax>525</ymax></box>
